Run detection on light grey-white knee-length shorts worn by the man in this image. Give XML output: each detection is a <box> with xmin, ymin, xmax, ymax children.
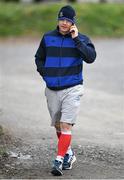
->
<box><xmin>45</xmin><ymin>85</ymin><xmax>83</xmax><ymax>126</ymax></box>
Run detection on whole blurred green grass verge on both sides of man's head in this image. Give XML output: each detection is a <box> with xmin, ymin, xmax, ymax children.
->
<box><xmin>0</xmin><ymin>3</ymin><xmax>124</xmax><ymax>37</ymax></box>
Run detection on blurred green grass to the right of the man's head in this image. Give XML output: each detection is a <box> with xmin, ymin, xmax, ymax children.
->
<box><xmin>77</xmin><ymin>4</ymin><xmax>124</xmax><ymax>37</ymax></box>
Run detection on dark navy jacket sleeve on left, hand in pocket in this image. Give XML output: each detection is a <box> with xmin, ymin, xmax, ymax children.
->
<box><xmin>35</xmin><ymin>37</ymin><xmax>46</xmax><ymax>76</ymax></box>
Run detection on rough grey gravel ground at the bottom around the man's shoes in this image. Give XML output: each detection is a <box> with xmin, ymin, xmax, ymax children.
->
<box><xmin>0</xmin><ymin>135</ymin><xmax>124</xmax><ymax>179</ymax></box>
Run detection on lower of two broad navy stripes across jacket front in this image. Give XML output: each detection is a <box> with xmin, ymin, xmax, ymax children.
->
<box><xmin>43</xmin><ymin>65</ymin><xmax>82</xmax><ymax>77</ymax></box>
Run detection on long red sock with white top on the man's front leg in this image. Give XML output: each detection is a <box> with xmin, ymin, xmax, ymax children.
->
<box><xmin>57</xmin><ymin>131</ymin><xmax>71</xmax><ymax>157</ymax></box>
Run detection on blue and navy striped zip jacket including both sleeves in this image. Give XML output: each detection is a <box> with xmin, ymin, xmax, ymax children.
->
<box><xmin>35</xmin><ymin>29</ymin><xmax>96</xmax><ymax>90</ymax></box>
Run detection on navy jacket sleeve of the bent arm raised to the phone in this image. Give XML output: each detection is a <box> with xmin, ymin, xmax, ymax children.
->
<box><xmin>74</xmin><ymin>36</ymin><xmax>96</xmax><ymax>63</ymax></box>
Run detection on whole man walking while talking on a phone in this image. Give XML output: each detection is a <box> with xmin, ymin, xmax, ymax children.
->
<box><xmin>35</xmin><ymin>5</ymin><xmax>96</xmax><ymax>176</ymax></box>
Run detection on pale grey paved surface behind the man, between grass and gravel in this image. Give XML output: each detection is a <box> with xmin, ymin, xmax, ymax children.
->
<box><xmin>0</xmin><ymin>39</ymin><xmax>124</xmax><ymax>146</ymax></box>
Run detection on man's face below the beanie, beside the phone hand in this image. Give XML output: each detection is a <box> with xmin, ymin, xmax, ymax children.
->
<box><xmin>58</xmin><ymin>19</ymin><xmax>72</xmax><ymax>34</ymax></box>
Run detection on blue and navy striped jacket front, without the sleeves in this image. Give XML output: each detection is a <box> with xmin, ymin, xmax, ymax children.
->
<box><xmin>41</xmin><ymin>28</ymin><xmax>83</xmax><ymax>90</ymax></box>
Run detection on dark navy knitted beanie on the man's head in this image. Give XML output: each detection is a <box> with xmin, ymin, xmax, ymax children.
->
<box><xmin>58</xmin><ymin>5</ymin><xmax>76</xmax><ymax>24</ymax></box>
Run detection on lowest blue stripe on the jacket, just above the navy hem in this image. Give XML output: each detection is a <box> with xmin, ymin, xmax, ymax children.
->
<box><xmin>44</xmin><ymin>73</ymin><xmax>82</xmax><ymax>87</ymax></box>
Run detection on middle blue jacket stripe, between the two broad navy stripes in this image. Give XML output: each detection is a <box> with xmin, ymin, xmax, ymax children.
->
<box><xmin>45</xmin><ymin>57</ymin><xmax>82</xmax><ymax>67</ymax></box>
